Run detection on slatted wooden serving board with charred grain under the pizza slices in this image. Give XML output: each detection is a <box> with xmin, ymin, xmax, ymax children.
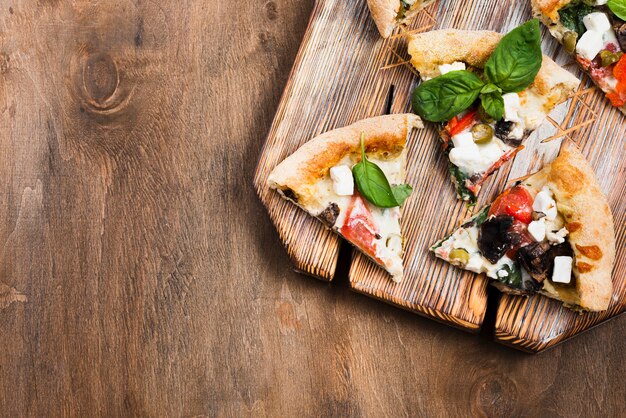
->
<box><xmin>254</xmin><ymin>0</ymin><xmax>626</xmax><ymax>352</ymax></box>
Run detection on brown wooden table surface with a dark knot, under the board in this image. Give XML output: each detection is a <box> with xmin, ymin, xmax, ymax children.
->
<box><xmin>0</xmin><ymin>0</ymin><xmax>626</xmax><ymax>417</ymax></box>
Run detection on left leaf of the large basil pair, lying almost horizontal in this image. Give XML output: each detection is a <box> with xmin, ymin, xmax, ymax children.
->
<box><xmin>413</xmin><ymin>70</ymin><xmax>485</xmax><ymax>122</ymax></box>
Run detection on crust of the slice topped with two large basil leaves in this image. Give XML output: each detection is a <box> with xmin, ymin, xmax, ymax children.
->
<box><xmin>408</xmin><ymin>29</ymin><xmax>580</xmax><ymax>106</ymax></box>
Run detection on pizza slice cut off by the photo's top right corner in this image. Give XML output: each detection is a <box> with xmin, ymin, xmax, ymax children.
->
<box><xmin>532</xmin><ymin>0</ymin><xmax>626</xmax><ymax>113</ymax></box>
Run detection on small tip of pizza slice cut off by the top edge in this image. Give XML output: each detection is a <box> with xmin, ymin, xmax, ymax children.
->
<box><xmin>367</xmin><ymin>0</ymin><xmax>434</xmax><ymax>38</ymax></box>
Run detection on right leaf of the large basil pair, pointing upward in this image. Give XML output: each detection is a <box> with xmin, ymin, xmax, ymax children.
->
<box><xmin>485</xmin><ymin>19</ymin><xmax>543</xmax><ymax>93</ymax></box>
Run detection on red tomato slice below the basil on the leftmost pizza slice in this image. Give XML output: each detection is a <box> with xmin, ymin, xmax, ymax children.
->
<box><xmin>341</xmin><ymin>194</ymin><xmax>378</xmax><ymax>258</ymax></box>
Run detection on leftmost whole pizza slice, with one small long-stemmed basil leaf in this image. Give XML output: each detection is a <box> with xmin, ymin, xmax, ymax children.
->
<box><xmin>268</xmin><ymin>114</ymin><xmax>422</xmax><ymax>282</ymax></box>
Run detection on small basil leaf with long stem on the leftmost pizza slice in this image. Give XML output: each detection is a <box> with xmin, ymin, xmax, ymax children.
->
<box><xmin>352</xmin><ymin>133</ymin><xmax>398</xmax><ymax>208</ymax></box>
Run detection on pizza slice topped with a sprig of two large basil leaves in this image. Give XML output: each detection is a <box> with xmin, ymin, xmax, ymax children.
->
<box><xmin>408</xmin><ymin>20</ymin><xmax>580</xmax><ymax>204</ymax></box>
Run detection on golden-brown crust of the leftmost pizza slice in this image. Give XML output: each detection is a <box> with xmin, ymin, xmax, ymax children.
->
<box><xmin>268</xmin><ymin>113</ymin><xmax>423</xmax><ymax>214</ymax></box>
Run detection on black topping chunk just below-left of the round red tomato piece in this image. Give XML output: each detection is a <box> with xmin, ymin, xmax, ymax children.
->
<box><xmin>478</xmin><ymin>215</ymin><xmax>515</xmax><ymax>264</ymax></box>
